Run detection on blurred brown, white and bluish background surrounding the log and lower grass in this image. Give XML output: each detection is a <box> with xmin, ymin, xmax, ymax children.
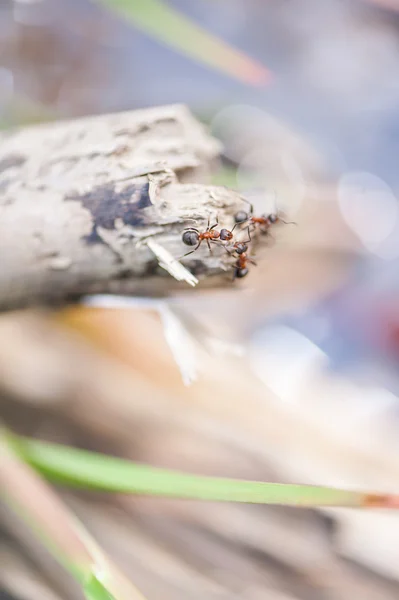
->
<box><xmin>0</xmin><ymin>0</ymin><xmax>399</xmax><ymax>600</ymax></box>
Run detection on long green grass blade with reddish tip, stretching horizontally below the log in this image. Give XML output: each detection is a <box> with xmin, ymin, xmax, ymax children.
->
<box><xmin>9</xmin><ymin>436</ymin><xmax>399</xmax><ymax>508</ymax></box>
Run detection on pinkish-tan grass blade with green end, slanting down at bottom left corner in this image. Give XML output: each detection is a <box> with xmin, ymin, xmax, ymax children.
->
<box><xmin>0</xmin><ymin>428</ymin><xmax>148</xmax><ymax>600</ymax></box>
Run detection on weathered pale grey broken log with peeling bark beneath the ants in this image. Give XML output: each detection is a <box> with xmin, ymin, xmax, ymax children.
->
<box><xmin>0</xmin><ymin>105</ymin><xmax>250</xmax><ymax>310</ymax></box>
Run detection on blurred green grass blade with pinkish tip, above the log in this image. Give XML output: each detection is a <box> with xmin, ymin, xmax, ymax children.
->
<box><xmin>91</xmin><ymin>0</ymin><xmax>271</xmax><ymax>85</ymax></box>
